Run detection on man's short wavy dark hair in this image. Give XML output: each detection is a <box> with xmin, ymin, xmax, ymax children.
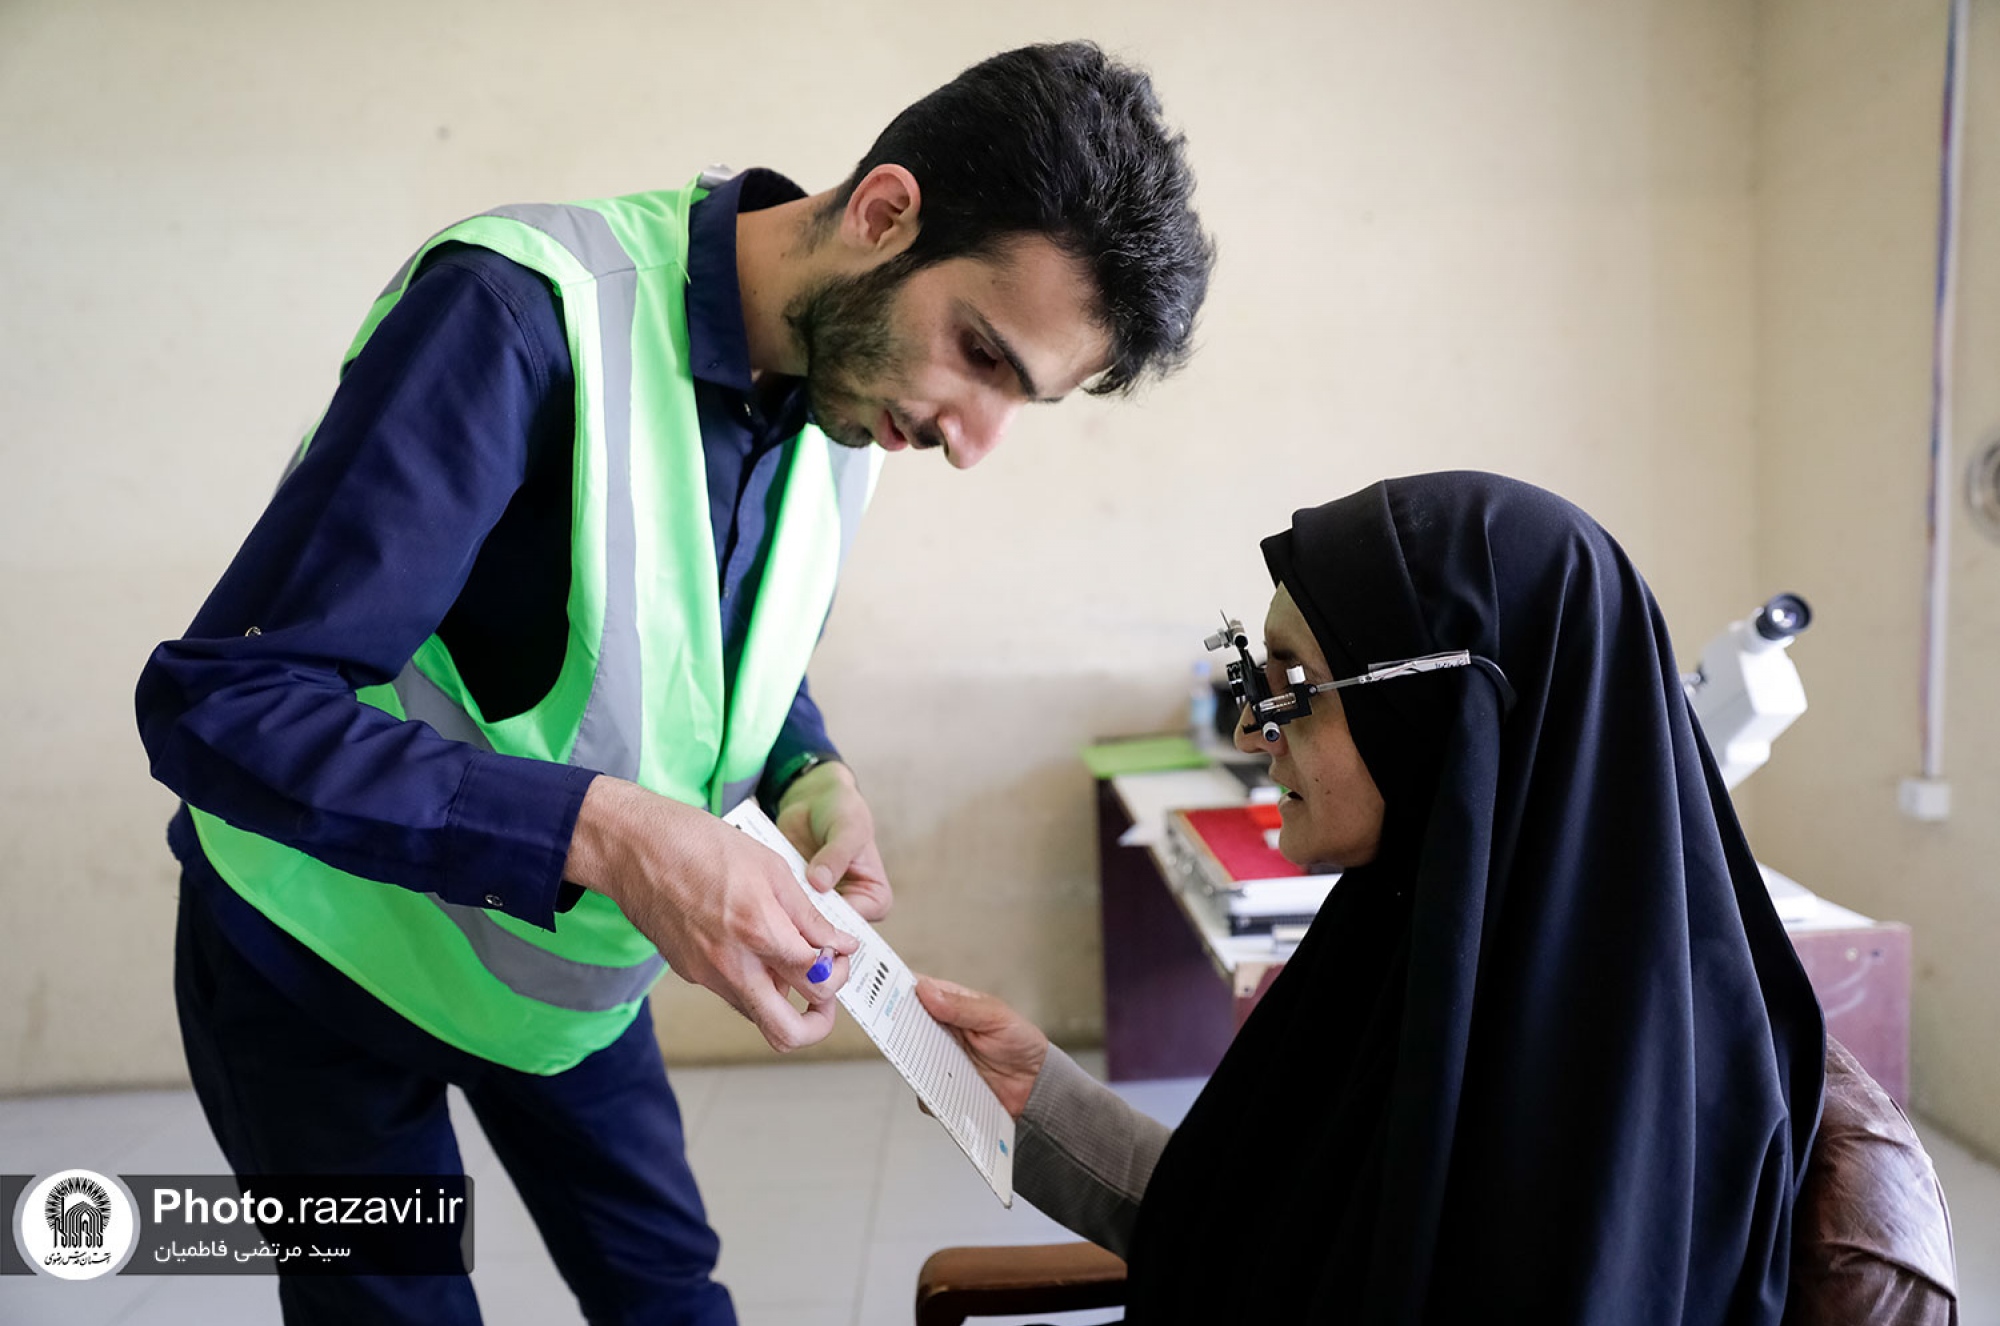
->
<box><xmin>824</xmin><ymin>42</ymin><xmax>1216</xmax><ymax>396</ymax></box>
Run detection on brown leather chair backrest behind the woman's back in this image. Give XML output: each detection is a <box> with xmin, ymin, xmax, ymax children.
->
<box><xmin>1784</xmin><ymin>1036</ymin><xmax>1958</xmax><ymax>1326</ymax></box>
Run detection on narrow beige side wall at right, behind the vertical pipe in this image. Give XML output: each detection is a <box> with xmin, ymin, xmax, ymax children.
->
<box><xmin>1756</xmin><ymin>0</ymin><xmax>2000</xmax><ymax>1154</ymax></box>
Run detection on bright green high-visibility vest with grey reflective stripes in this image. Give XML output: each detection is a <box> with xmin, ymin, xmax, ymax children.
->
<box><xmin>194</xmin><ymin>184</ymin><xmax>880</xmax><ymax>1074</ymax></box>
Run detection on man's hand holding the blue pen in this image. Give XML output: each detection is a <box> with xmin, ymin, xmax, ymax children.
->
<box><xmin>562</xmin><ymin>776</ymin><xmax>860</xmax><ymax>1052</ymax></box>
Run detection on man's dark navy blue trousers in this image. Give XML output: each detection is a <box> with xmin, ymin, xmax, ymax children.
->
<box><xmin>174</xmin><ymin>878</ymin><xmax>736</xmax><ymax>1326</ymax></box>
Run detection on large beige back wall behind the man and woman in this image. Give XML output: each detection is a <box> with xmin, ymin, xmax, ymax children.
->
<box><xmin>0</xmin><ymin>0</ymin><xmax>1760</xmax><ymax>1090</ymax></box>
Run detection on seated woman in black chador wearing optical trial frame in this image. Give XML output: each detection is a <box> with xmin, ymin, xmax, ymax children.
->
<box><xmin>920</xmin><ymin>474</ymin><xmax>1824</xmax><ymax>1324</ymax></box>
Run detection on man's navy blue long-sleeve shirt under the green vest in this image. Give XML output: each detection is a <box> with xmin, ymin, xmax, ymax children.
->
<box><xmin>138</xmin><ymin>170</ymin><xmax>832</xmax><ymax>956</ymax></box>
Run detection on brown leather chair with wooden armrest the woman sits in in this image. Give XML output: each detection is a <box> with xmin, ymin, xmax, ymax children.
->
<box><xmin>916</xmin><ymin>1036</ymin><xmax>1958</xmax><ymax>1326</ymax></box>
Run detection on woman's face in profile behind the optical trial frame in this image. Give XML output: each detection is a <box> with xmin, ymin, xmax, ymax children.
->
<box><xmin>1236</xmin><ymin>584</ymin><xmax>1382</xmax><ymax>870</ymax></box>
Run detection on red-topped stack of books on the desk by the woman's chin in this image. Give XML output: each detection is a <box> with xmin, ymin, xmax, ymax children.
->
<box><xmin>1162</xmin><ymin>804</ymin><xmax>1340</xmax><ymax>934</ymax></box>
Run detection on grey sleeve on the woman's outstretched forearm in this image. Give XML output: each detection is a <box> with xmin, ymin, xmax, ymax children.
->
<box><xmin>1014</xmin><ymin>1046</ymin><xmax>1174</xmax><ymax>1256</ymax></box>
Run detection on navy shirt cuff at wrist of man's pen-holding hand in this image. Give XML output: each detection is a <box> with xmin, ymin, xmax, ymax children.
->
<box><xmin>438</xmin><ymin>752</ymin><xmax>598</xmax><ymax>930</ymax></box>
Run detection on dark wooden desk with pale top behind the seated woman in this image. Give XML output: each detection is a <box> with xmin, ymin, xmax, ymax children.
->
<box><xmin>1096</xmin><ymin>780</ymin><xmax>1910</xmax><ymax>1104</ymax></box>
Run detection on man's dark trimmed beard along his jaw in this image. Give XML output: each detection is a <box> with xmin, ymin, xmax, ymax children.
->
<box><xmin>784</xmin><ymin>256</ymin><xmax>916</xmax><ymax>448</ymax></box>
